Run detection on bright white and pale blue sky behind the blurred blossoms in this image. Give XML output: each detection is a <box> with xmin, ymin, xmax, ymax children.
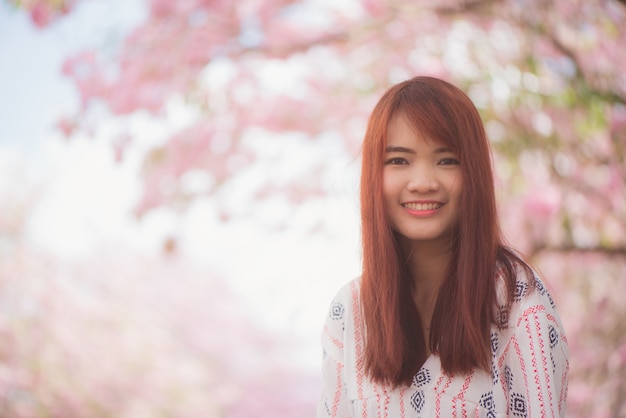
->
<box><xmin>0</xmin><ymin>0</ymin><xmax>360</xmax><ymax>367</ymax></box>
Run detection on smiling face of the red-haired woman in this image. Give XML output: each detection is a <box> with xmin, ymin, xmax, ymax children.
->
<box><xmin>383</xmin><ymin>113</ymin><xmax>462</xmax><ymax>247</ymax></box>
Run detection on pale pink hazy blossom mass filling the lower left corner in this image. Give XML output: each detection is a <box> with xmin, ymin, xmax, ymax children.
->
<box><xmin>0</xmin><ymin>166</ymin><xmax>317</xmax><ymax>418</ymax></box>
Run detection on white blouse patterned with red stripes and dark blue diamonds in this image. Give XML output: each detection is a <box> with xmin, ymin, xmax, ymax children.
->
<box><xmin>317</xmin><ymin>275</ymin><xmax>569</xmax><ymax>418</ymax></box>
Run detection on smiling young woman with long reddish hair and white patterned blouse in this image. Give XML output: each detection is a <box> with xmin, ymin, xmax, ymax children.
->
<box><xmin>317</xmin><ymin>77</ymin><xmax>569</xmax><ymax>418</ymax></box>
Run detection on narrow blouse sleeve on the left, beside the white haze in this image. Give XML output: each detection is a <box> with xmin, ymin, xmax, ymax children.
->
<box><xmin>317</xmin><ymin>294</ymin><xmax>350</xmax><ymax>418</ymax></box>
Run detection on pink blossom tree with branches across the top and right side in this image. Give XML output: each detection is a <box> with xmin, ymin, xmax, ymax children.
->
<box><xmin>7</xmin><ymin>0</ymin><xmax>626</xmax><ymax>417</ymax></box>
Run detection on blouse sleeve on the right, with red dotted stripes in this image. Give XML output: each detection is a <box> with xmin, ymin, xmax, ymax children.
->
<box><xmin>503</xmin><ymin>303</ymin><xmax>569</xmax><ymax>417</ymax></box>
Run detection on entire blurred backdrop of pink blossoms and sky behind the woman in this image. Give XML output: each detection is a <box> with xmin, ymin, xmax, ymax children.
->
<box><xmin>0</xmin><ymin>0</ymin><xmax>626</xmax><ymax>418</ymax></box>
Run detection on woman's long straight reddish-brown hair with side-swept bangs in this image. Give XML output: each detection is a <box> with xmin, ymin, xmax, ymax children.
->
<box><xmin>361</xmin><ymin>77</ymin><xmax>527</xmax><ymax>386</ymax></box>
